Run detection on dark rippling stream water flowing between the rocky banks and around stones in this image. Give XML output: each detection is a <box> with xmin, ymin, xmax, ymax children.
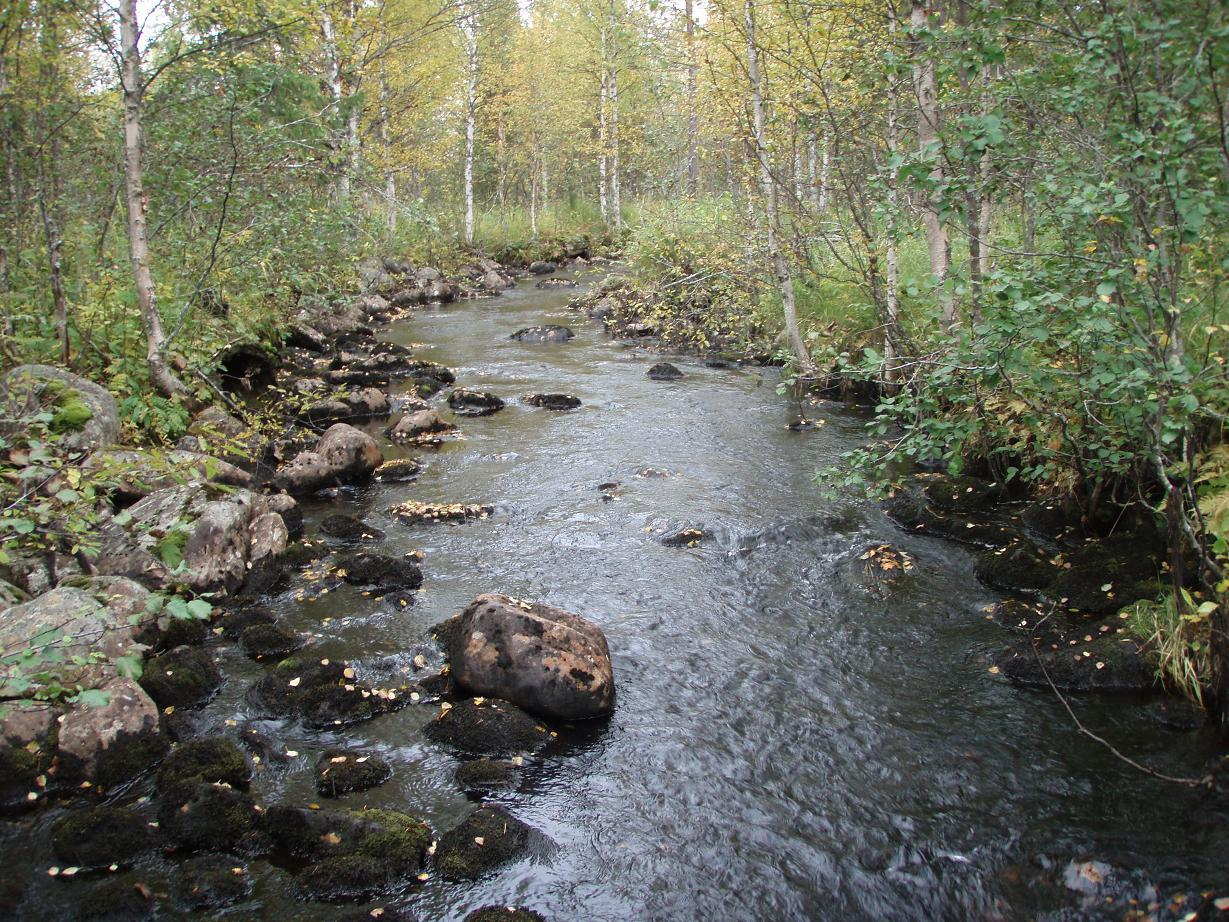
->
<box><xmin>9</xmin><ymin>276</ymin><xmax>1229</xmax><ymax>922</ymax></box>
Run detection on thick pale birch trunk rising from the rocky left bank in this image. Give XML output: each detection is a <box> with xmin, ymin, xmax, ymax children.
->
<box><xmin>119</xmin><ymin>0</ymin><xmax>188</xmax><ymax>397</ymax></box>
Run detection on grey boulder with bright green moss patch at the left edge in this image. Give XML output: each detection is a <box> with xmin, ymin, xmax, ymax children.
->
<box><xmin>0</xmin><ymin>365</ymin><xmax>119</xmax><ymax>451</ymax></box>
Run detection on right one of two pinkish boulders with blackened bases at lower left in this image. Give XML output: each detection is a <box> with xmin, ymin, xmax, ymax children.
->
<box><xmin>58</xmin><ymin>677</ymin><xmax>167</xmax><ymax>789</ymax></box>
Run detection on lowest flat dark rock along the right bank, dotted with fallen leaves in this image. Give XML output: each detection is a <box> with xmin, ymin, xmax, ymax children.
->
<box><xmin>992</xmin><ymin>633</ymin><xmax>1158</xmax><ymax>692</ymax></box>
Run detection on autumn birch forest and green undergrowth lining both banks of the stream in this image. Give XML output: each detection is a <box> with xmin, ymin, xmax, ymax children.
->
<box><xmin>7</xmin><ymin>0</ymin><xmax>1229</xmax><ymax>720</ymax></box>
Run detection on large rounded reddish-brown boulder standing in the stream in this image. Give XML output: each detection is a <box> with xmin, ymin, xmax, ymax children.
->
<box><xmin>451</xmin><ymin>594</ymin><xmax>615</xmax><ymax>720</ymax></box>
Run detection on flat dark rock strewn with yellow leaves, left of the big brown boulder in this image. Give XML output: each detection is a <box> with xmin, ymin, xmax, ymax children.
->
<box><xmin>249</xmin><ymin>654</ymin><xmax>409</xmax><ymax>729</ymax></box>
